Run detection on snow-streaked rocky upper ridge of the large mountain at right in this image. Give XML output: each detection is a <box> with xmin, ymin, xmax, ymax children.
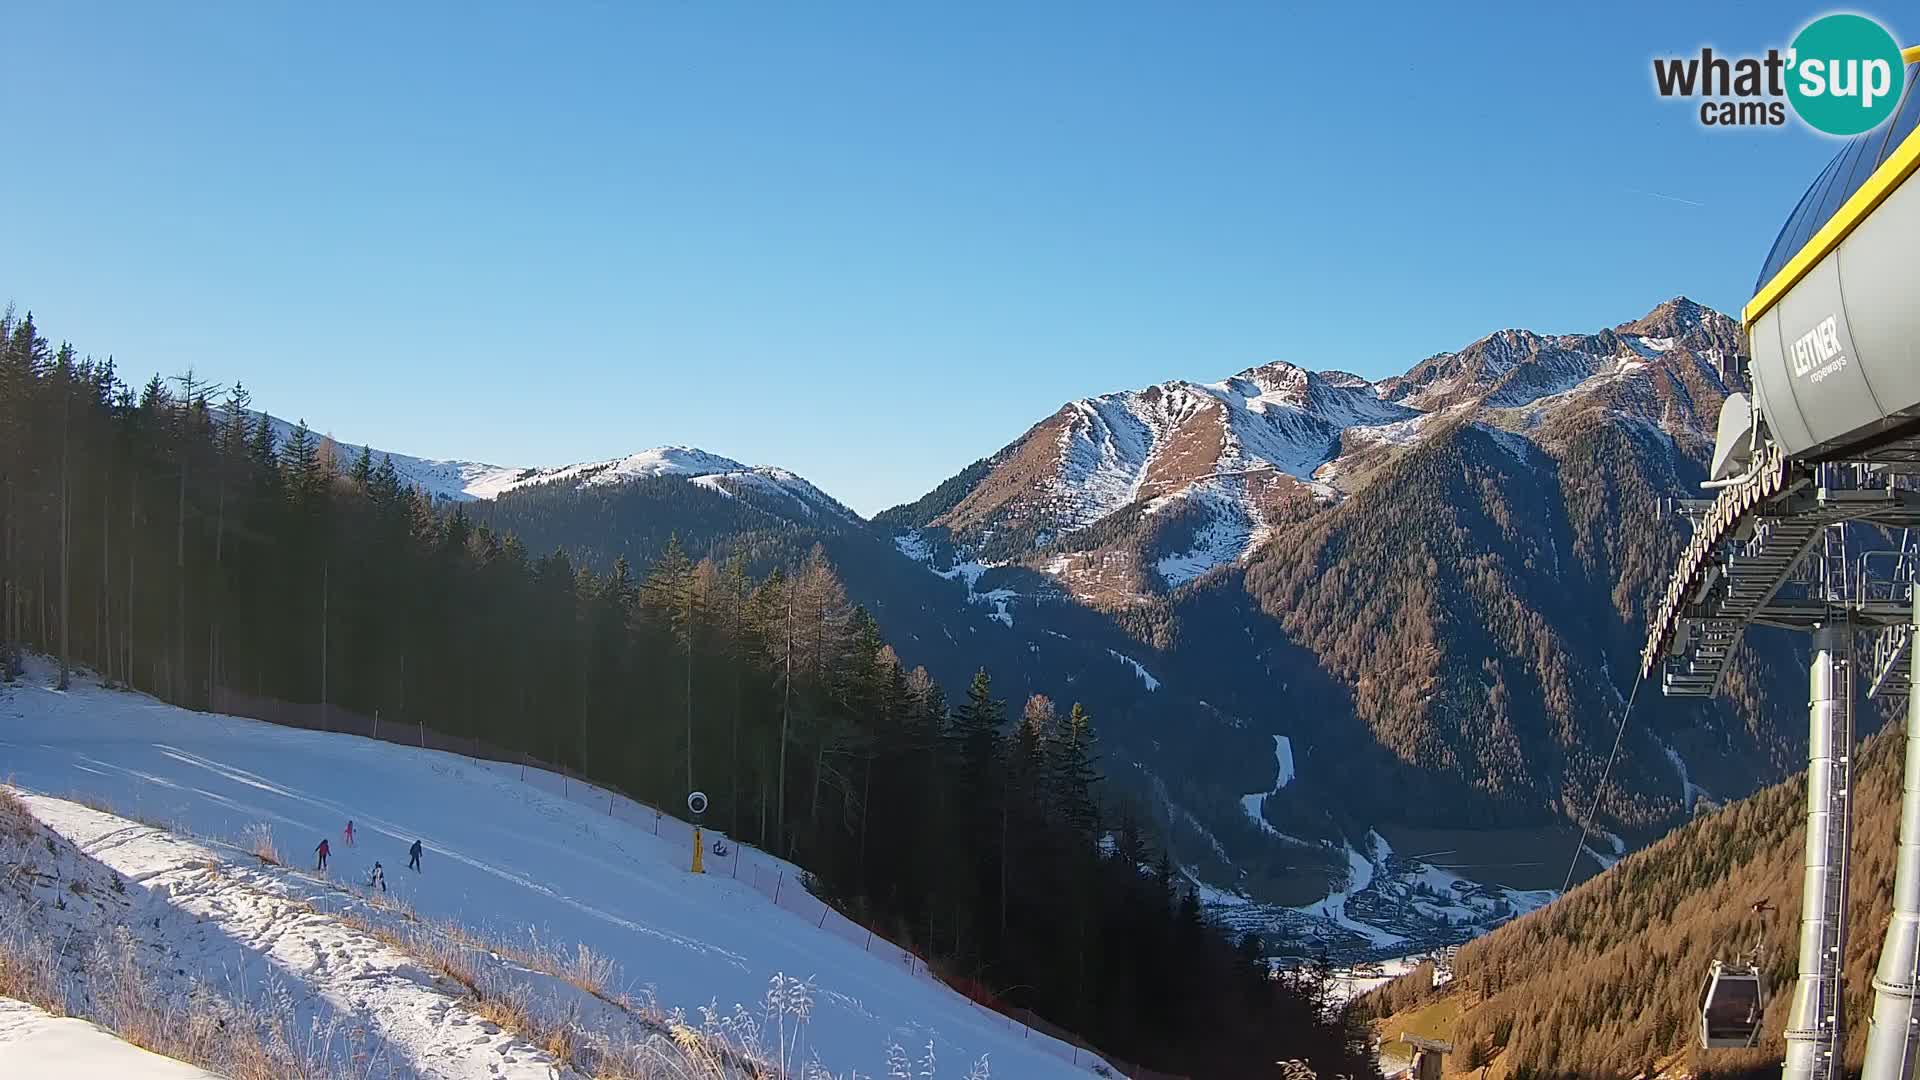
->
<box><xmin>887</xmin><ymin>298</ymin><xmax>1738</xmax><ymax>600</ymax></box>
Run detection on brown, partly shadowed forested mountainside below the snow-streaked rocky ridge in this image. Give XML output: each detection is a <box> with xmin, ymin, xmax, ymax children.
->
<box><xmin>1244</xmin><ymin>409</ymin><xmax>1795</xmax><ymax>832</ymax></box>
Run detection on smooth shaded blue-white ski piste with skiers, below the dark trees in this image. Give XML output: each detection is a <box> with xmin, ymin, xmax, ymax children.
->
<box><xmin>0</xmin><ymin>663</ymin><xmax>1100</xmax><ymax>1078</ymax></box>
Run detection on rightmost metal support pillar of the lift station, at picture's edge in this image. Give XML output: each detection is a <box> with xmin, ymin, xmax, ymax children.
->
<box><xmin>1860</xmin><ymin>596</ymin><xmax>1920</xmax><ymax>1080</ymax></box>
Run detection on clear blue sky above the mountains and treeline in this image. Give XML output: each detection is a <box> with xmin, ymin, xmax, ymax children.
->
<box><xmin>0</xmin><ymin>0</ymin><xmax>1889</xmax><ymax>511</ymax></box>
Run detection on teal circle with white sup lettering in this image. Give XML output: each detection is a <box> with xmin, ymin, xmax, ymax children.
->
<box><xmin>1788</xmin><ymin>15</ymin><xmax>1907</xmax><ymax>135</ymax></box>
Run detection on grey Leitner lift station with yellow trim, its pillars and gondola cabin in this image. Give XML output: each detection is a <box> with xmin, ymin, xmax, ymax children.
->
<box><xmin>1640</xmin><ymin>48</ymin><xmax>1920</xmax><ymax>1080</ymax></box>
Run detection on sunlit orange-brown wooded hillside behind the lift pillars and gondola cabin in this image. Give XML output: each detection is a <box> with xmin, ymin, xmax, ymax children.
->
<box><xmin>1363</xmin><ymin>711</ymin><xmax>1903</xmax><ymax>1076</ymax></box>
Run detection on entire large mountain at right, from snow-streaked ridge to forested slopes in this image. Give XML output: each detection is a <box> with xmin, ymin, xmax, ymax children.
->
<box><xmin>890</xmin><ymin>298</ymin><xmax>1803</xmax><ymax>849</ymax></box>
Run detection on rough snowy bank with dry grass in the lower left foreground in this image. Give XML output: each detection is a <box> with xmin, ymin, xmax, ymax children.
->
<box><xmin>0</xmin><ymin>780</ymin><xmax>572</xmax><ymax>1080</ymax></box>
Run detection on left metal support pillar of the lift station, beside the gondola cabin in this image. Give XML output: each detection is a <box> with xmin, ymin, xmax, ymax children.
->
<box><xmin>1782</xmin><ymin>625</ymin><xmax>1853</xmax><ymax>1080</ymax></box>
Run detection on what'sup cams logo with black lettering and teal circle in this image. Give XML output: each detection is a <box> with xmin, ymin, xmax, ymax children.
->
<box><xmin>1653</xmin><ymin>13</ymin><xmax>1907</xmax><ymax>136</ymax></box>
